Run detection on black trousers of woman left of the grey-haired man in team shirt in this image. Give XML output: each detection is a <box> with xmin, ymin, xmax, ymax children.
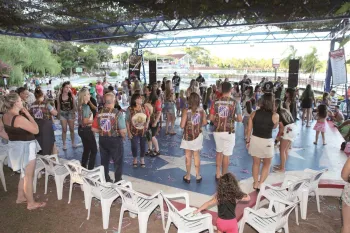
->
<box><xmin>78</xmin><ymin>127</ymin><xmax>97</xmax><ymax>170</ymax></box>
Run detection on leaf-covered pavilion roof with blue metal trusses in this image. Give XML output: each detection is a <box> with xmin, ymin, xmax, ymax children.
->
<box><xmin>0</xmin><ymin>0</ymin><xmax>350</xmax><ymax>44</ymax></box>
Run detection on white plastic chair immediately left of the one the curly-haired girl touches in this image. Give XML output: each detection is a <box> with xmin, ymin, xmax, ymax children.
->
<box><xmin>116</xmin><ymin>187</ymin><xmax>164</xmax><ymax>233</ymax></box>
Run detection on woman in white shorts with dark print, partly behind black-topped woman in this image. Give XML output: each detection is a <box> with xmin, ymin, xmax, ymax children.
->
<box><xmin>274</xmin><ymin>99</ymin><xmax>296</xmax><ymax>172</ymax></box>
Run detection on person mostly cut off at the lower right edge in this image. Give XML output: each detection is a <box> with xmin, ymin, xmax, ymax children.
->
<box><xmin>341</xmin><ymin>158</ymin><xmax>350</xmax><ymax>233</ymax></box>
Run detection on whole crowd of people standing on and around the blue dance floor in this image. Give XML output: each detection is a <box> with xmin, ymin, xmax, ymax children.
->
<box><xmin>0</xmin><ymin>72</ymin><xmax>350</xmax><ymax>233</ymax></box>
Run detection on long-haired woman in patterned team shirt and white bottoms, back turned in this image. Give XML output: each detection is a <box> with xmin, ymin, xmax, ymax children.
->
<box><xmin>180</xmin><ymin>92</ymin><xmax>207</xmax><ymax>184</ymax></box>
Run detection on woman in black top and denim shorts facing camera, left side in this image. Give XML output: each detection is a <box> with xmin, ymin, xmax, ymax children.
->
<box><xmin>57</xmin><ymin>81</ymin><xmax>76</xmax><ymax>150</ymax></box>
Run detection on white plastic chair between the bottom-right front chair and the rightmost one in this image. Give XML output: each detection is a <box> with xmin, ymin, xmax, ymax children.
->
<box><xmin>255</xmin><ymin>180</ymin><xmax>305</xmax><ymax>225</ymax></box>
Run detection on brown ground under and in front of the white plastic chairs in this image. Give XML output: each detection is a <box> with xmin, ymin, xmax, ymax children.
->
<box><xmin>0</xmin><ymin>167</ymin><xmax>341</xmax><ymax>233</ymax></box>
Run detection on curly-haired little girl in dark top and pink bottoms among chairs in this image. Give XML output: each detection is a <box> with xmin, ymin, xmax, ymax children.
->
<box><xmin>194</xmin><ymin>173</ymin><xmax>250</xmax><ymax>233</ymax></box>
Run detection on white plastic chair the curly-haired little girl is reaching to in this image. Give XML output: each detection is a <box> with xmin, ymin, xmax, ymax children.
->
<box><xmin>162</xmin><ymin>193</ymin><xmax>214</xmax><ymax>233</ymax></box>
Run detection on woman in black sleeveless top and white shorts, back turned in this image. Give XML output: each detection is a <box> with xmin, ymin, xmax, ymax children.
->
<box><xmin>246</xmin><ymin>93</ymin><xmax>279</xmax><ymax>190</ymax></box>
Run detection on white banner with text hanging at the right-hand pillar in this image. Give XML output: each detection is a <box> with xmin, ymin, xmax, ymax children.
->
<box><xmin>329</xmin><ymin>49</ymin><xmax>347</xmax><ymax>85</ymax></box>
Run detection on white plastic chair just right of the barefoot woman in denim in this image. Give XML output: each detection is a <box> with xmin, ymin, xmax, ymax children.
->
<box><xmin>39</xmin><ymin>155</ymin><xmax>69</xmax><ymax>200</ymax></box>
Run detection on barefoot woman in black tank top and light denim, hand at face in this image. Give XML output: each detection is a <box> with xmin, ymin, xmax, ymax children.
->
<box><xmin>0</xmin><ymin>93</ymin><xmax>46</xmax><ymax>210</ymax></box>
